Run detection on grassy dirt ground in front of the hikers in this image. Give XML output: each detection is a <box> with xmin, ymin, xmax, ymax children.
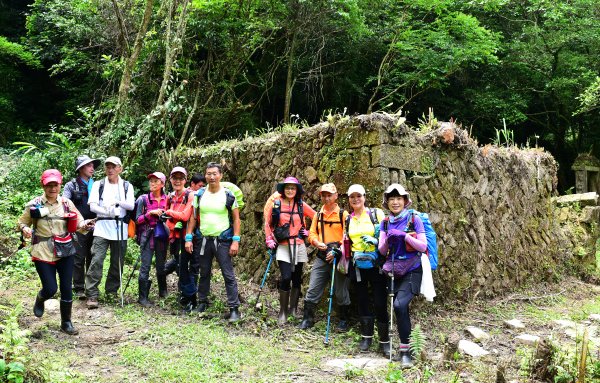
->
<box><xmin>0</xmin><ymin>278</ymin><xmax>600</xmax><ymax>382</ymax></box>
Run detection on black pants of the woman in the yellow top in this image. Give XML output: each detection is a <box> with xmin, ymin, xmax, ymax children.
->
<box><xmin>350</xmin><ymin>267</ymin><xmax>390</xmax><ymax>322</ymax></box>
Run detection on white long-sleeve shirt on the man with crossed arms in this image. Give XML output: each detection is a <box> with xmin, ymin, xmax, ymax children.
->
<box><xmin>88</xmin><ymin>177</ymin><xmax>135</xmax><ymax>241</ymax></box>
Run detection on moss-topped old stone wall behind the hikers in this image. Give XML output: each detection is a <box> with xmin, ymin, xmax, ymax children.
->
<box><xmin>173</xmin><ymin>114</ymin><xmax>588</xmax><ymax>298</ymax></box>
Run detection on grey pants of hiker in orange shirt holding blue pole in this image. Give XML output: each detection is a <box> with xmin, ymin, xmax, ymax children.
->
<box><xmin>304</xmin><ymin>257</ymin><xmax>350</xmax><ymax>306</ymax></box>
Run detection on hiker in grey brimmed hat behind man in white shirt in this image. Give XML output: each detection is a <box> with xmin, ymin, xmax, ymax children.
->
<box><xmin>63</xmin><ymin>155</ymin><xmax>100</xmax><ymax>299</ymax></box>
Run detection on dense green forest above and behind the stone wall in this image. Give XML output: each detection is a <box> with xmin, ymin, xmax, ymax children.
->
<box><xmin>0</xmin><ymin>0</ymin><xmax>600</xmax><ymax>191</ymax></box>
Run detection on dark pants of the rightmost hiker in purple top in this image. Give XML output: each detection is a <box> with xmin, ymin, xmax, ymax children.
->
<box><xmin>394</xmin><ymin>267</ymin><xmax>423</xmax><ymax>344</ymax></box>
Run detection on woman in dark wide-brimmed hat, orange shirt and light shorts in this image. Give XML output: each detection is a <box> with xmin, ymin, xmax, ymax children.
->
<box><xmin>264</xmin><ymin>177</ymin><xmax>315</xmax><ymax>325</ymax></box>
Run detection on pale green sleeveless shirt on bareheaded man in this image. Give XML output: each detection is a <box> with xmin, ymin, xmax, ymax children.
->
<box><xmin>200</xmin><ymin>186</ymin><xmax>238</xmax><ymax>237</ymax></box>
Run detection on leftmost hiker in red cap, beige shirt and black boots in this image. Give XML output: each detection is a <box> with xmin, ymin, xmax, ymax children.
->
<box><xmin>18</xmin><ymin>169</ymin><xmax>94</xmax><ymax>335</ymax></box>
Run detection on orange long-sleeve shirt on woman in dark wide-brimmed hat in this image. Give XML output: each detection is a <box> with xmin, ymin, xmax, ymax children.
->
<box><xmin>263</xmin><ymin>193</ymin><xmax>316</xmax><ymax>245</ymax></box>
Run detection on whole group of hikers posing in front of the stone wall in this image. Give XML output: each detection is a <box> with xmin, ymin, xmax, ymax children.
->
<box><xmin>18</xmin><ymin>155</ymin><xmax>435</xmax><ymax>366</ymax></box>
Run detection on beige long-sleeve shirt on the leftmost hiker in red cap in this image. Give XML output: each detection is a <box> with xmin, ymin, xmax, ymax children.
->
<box><xmin>18</xmin><ymin>195</ymin><xmax>86</xmax><ymax>263</ymax></box>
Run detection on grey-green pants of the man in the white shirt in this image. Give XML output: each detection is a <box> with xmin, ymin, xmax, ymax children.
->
<box><xmin>85</xmin><ymin>237</ymin><xmax>127</xmax><ymax>298</ymax></box>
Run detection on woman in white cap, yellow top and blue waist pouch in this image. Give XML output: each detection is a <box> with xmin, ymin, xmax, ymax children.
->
<box><xmin>344</xmin><ymin>184</ymin><xmax>390</xmax><ymax>356</ymax></box>
